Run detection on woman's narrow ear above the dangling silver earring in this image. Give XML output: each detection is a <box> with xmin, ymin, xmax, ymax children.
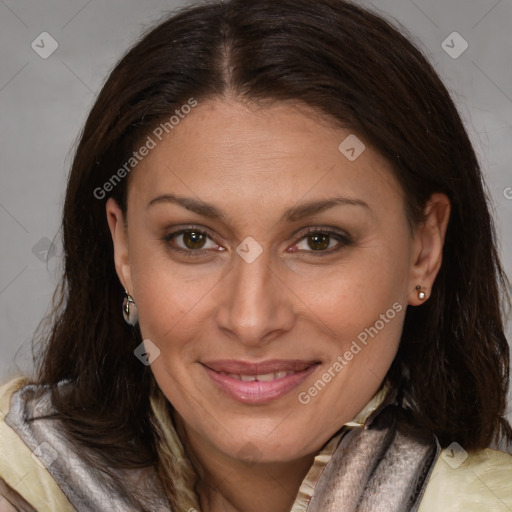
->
<box><xmin>105</xmin><ymin>197</ymin><xmax>133</xmax><ymax>294</ymax></box>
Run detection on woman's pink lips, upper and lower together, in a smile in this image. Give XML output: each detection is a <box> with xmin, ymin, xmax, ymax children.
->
<box><xmin>202</xmin><ymin>360</ymin><xmax>319</xmax><ymax>404</ymax></box>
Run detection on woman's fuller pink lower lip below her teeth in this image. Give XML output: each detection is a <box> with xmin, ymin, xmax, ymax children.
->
<box><xmin>203</xmin><ymin>364</ymin><xmax>319</xmax><ymax>404</ymax></box>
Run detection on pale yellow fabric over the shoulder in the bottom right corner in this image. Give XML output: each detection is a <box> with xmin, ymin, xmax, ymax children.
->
<box><xmin>418</xmin><ymin>444</ymin><xmax>512</xmax><ymax>512</ymax></box>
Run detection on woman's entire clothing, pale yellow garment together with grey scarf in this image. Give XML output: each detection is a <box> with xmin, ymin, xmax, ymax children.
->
<box><xmin>0</xmin><ymin>379</ymin><xmax>512</xmax><ymax>512</ymax></box>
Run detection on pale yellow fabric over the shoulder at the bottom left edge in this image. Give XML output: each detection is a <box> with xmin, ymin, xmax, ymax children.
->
<box><xmin>0</xmin><ymin>377</ymin><xmax>75</xmax><ymax>512</ymax></box>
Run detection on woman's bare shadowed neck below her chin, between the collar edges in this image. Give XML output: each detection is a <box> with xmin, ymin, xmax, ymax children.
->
<box><xmin>177</xmin><ymin>420</ymin><xmax>314</xmax><ymax>512</ymax></box>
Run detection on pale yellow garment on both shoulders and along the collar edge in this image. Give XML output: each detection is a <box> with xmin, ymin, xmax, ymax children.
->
<box><xmin>0</xmin><ymin>378</ymin><xmax>512</xmax><ymax>512</ymax></box>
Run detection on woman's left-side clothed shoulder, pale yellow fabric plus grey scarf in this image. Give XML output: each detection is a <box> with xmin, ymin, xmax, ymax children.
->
<box><xmin>0</xmin><ymin>378</ymin><xmax>172</xmax><ymax>512</ymax></box>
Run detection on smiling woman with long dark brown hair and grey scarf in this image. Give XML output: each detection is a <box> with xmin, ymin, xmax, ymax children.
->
<box><xmin>0</xmin><ymin>0</ymin><xmax>512</xmax><ymax>512</ymax></box>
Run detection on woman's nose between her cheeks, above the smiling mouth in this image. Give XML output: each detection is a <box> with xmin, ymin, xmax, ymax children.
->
<box><xmin>216</xmin><ymin>251</ymin><xmax>295</xmax><ymax>347</ymax></box>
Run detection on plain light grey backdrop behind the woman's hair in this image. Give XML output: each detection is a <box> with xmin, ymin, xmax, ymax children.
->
<box><xmin>0</xmin><ymin>0</ymin><xmax>512</xmax><ymax>430</ymax></box>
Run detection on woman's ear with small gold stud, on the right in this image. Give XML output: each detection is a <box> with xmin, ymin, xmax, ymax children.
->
<box><xmin>408</xmin><ymin>193</ymin><xmax>451</xmax><ymax>306</ymax></box>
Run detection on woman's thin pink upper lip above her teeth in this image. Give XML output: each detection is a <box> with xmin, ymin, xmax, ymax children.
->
<box><xmin>202</xmin><ymin>359</ymin><xmax>319</xmax><ymax>375</ymax></box>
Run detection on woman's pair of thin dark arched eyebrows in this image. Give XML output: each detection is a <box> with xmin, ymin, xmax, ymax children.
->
<box><xmin>147</xmin><ymin>194</ymin><xmax>370</xmax><ymax>222</ymax></box>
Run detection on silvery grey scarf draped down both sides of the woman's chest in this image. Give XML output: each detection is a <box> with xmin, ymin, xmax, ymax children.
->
<box><xmin>5</xmin><ymin>383</ymin><xmax>440</xmax><ymax>512</ymax></box>
